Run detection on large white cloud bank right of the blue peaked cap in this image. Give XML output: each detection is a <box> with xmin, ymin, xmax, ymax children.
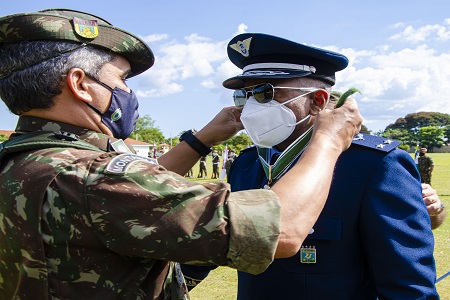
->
<box><xmin>336</xmin><ymin>45</ymin><xmax>450</xmax><ymax>131</ymax></box>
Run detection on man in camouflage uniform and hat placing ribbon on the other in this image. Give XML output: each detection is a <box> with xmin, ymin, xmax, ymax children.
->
<box><xmin>0</xmin><ymin>9</ymin><xmax>362</xmax><ymax>299</ymax></box>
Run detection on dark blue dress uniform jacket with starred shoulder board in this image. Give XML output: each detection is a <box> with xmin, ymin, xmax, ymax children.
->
<box><xmin>229</xmin><ymin>134</ymin><xmax>439</xmax><ymax>300</ymax></box>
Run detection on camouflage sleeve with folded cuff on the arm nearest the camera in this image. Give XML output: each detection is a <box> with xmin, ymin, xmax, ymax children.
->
<box><xmin>85</xmin><ymin>154</ymin><xmax>280</xmax><ymax>273</ymax></box>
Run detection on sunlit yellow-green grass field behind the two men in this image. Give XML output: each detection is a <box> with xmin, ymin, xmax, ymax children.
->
<box><xmin>187</xmin><ymin>153</ymin><xmax>450</xmax><ymax>300</ymax></box>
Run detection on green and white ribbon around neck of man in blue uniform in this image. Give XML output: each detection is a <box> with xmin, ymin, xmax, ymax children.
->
<box><xmin>256</xmin><ymin>127</ymin><xmax>313</xmax><ymax>186</ymax></box>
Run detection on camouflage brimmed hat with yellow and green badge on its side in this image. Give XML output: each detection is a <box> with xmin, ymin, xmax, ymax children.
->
<box><xmin>0</xmin><ymin>9</ymin><xmax>155</xmax><ymax>78</ymax></box>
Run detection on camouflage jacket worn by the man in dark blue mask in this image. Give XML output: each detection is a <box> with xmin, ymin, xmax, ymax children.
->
<box><xmin>0</xmin><ymin>117</ymin><xmax>280</xmax><ymax>300</ymax></box>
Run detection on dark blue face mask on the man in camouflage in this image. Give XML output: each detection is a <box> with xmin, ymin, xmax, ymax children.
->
<box><xmin>86</xmin><ymin>74</ymin><xmax>139</xmax><ymax>140</ymax></box>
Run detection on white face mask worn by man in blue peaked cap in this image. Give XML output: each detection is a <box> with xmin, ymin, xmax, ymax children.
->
<box><xmin>241</xmin><ymin>95</ymin><xmax>310</xmax><ymax>148</ymax></box>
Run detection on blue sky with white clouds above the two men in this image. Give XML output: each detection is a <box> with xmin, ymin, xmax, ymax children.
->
<box><xmin>0</xmin><ymin>0</ymin><xmax>450</xmax><ymax>137</ymax></box>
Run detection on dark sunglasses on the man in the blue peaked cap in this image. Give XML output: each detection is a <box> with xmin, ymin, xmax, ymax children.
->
<box><xmin>233</xmin><ymin>83</ymin><xmax>317</xmax><ymax>107</ymax></box>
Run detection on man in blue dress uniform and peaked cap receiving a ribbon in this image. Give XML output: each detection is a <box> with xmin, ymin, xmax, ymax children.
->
<box><xmin>182</xmin><ymin>33</ymin><xmax>439</xmax><ymax>300</ymax></box>
